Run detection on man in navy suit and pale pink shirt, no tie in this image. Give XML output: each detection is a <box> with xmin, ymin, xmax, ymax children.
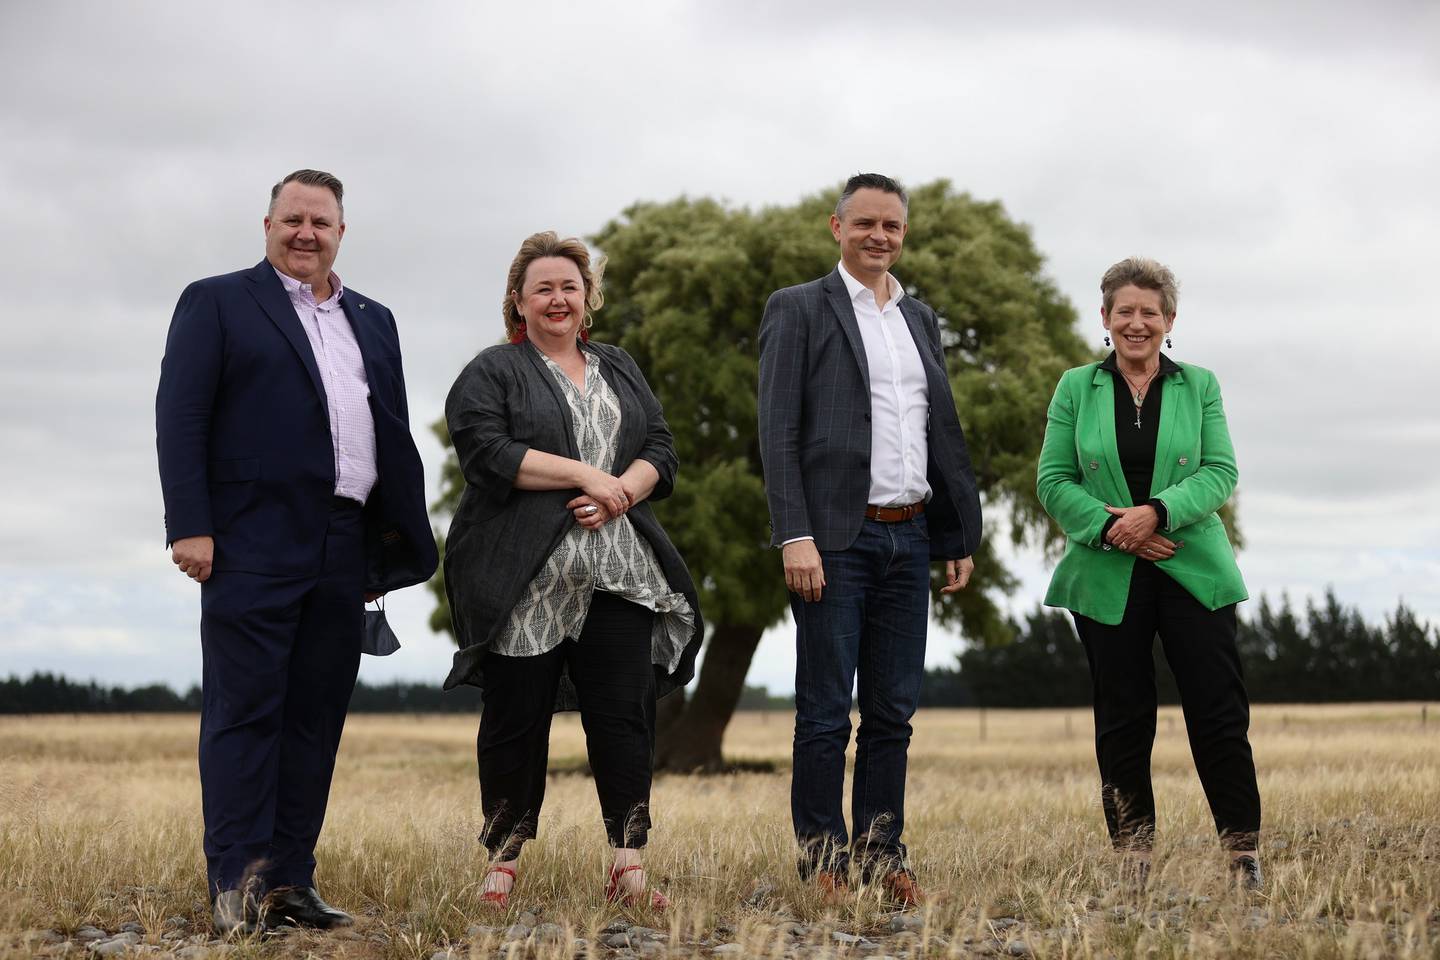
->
<box><xmin>156</xmin><ymin>170</ymin><xmax>436</xmax><ymax>933</ymax></box>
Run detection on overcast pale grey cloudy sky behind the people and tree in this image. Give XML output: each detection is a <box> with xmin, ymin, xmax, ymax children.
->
<box><xmin>0</xmin><ymin>0</ymin><xmax>1440</xmax><ymax>689</ymax></box>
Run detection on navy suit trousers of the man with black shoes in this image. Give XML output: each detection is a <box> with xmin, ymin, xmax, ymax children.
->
<box><xmin>200</xmin><ymin>498</ymin><xmax>364</xmax><ymax>898</ymax></box>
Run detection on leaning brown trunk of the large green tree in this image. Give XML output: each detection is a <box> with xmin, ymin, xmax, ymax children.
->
<box><xmin>655</xmin><ymin>623</ymin><xmax>763</xmax><ymax>773</ymax></box>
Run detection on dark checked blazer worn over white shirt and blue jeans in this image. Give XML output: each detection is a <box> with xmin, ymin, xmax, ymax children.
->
<box><xmin>759</xmin><ymin>268</ymin><xmax>981</xmax><ymax>560</ymax></box>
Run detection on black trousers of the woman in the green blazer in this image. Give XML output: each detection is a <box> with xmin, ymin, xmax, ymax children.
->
<box><xmin>1074</xmin><ymin>560</ymin><xmax>1260</xmax><ymax>851</ymax></box>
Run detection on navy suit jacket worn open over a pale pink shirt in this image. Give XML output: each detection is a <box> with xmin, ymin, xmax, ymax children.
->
<box><xmin>156</xmin><ymin>261</ymin><xmax>436</xmax><ymax>593</ymax></box>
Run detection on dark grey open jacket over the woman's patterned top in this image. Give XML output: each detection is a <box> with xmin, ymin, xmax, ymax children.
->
<box><xmin>445</xmin><ymin>341</ymin><xmax>704</xmax><ymax>710</ymax></box>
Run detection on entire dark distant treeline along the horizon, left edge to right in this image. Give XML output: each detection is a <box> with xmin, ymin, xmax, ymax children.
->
<box><xmin>0</xmin><ymin>593</ymin><xmax>1440</xmax><ymax>714</ymax></box>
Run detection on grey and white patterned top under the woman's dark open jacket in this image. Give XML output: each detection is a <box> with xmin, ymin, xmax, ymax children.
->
<box><xmin>491</xmin><ymin>350</ymin><xmax>696</xmax><ymax>674</ymax></box>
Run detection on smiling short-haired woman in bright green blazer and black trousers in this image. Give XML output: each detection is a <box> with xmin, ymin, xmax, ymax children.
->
<box><xmin>1038</xmin><ymin>258</ymin><xmax>1261</xmax><ymax>888</ymax></box>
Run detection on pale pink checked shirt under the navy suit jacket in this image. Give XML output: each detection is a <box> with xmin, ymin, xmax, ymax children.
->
<box><xmin>275</xmin><ymin>271</ymin><xmax>376</xmax><ymax>504</ymax></box>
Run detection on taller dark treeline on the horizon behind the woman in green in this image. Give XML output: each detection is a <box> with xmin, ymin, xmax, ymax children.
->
<box><xmin>920</xmin><ymin>592</ymin><xmax>1440</xmax><ymax>707</ymax></box>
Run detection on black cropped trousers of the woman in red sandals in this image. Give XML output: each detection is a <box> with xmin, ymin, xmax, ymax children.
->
<box><xmin>475</xmin><ymin>590</ymin><xmax>655</xmax><ymax>859</ymax></box>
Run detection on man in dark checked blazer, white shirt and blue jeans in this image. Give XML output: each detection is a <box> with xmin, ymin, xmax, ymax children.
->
<box><xmin>759</xmin><ymin>174</ymin><xmax>981</xmax><ymax>905</ymax></box>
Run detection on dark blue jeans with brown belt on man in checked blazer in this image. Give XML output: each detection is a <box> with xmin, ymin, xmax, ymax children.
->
<box><xmin>791</xmin><ymin>514</ymin><xmax>930</xmax><ymax>879</ymax></box>
